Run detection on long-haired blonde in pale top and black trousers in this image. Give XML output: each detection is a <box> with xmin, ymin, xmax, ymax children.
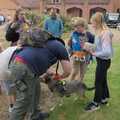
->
<box><xmin>85</xmin><ymin>12</ymin><xmax>113</xmax><ymax>111</ymax></box>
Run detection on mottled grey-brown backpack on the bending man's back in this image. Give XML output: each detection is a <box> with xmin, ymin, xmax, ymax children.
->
<box><xmin>20</xmin><ymin>27</ymin><xmax>65</xmax><ymax>47</ymax></box>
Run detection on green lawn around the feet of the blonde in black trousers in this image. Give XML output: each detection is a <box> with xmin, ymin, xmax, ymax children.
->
<box><xmin>49</xmin><ymin>43</ymin><xmax>120</xmax><ymax>120</ymax></box>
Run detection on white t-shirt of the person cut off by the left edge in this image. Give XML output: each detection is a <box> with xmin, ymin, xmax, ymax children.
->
<box><xmin>0</xmin><ymin>46</ymin><xmax>17</xmax><ymax>80</ymax></box>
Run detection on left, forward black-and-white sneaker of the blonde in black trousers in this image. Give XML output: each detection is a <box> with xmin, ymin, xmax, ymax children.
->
<box><xmin>85</xmin><ymin>101</ymin><xmax>100</xmax><ymax>112</ymax></box>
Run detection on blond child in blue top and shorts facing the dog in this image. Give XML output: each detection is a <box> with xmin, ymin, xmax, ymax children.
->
<box><xmin>69</xmin><ymin>18</ymin><xmax>94</xmax><ymax>82</ymax></box>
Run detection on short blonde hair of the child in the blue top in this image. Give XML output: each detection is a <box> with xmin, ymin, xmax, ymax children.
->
<box><xmin>71</xmin><ymin>17</ymin><xmax>88</xmax><ymax>29</ymax></box>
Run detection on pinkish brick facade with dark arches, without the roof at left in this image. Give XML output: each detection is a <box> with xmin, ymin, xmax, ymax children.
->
<box><xmin>40</xmin><ymin>0</ymin><xmax>120</xmax><ymax>20</ymax></box>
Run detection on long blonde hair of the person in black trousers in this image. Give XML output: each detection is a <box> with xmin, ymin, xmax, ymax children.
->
<box><xmin>91</xmin><ymin>12</ymin><xmax>108</xmax><ymax>30</ymax></box>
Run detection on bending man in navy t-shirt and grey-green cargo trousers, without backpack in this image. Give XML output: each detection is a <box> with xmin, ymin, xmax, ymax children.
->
<box><xmin>10</xmin><ymin>28</ymin><xmax>71</xmax><ymax>120</ymax></box>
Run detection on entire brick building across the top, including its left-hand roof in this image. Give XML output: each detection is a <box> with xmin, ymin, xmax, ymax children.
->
<box><xmin>0</xmin><ymin>0</ymin><xmax>120</xmax><ymax>20</ymax></box>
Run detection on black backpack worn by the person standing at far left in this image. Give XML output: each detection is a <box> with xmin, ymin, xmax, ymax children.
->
<box><xmin>5</xmin><ymin>23</ymin><xmax>20</xmax><ymax>42</ymax></box>
